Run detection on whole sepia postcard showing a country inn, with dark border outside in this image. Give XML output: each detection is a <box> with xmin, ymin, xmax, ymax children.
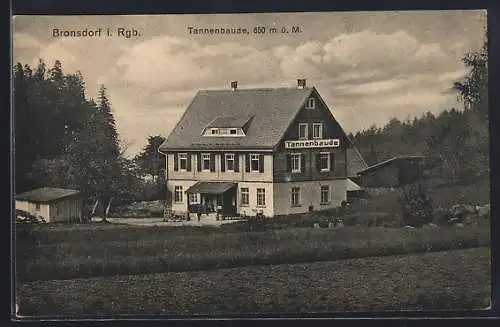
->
<box><xmin>12</xmin><ymin>10</ymin><xmax>491</xmax><ymax>320</ymax></box>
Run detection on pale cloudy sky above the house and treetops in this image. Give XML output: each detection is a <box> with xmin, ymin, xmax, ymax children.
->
<box><xmin>12</xmin><ymin>10</ymin><xmax>486</xmax><ymax>156</ymax></box>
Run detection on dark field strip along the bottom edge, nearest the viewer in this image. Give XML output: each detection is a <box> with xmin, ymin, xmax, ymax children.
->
<box><xmin>17</xmin><ymin>247</ymin><xmax>491</xmax><ymax>316</ymax></box>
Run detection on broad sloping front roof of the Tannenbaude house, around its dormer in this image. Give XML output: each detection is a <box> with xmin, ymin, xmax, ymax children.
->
<box><xmin>160</xmin><ymin>87</ymin><xmax>315</xmax><ymax>151</ymax></box>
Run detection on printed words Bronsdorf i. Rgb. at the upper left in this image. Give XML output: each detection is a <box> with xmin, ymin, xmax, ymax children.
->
<box><xmin>52</xmin><ymin>27</ymin><xmax>141</xmax><ymax>39</ymax></box>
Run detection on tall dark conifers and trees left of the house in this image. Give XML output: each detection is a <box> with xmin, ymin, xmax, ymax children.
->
<box><xmin>13</xmin><ymin>60</ymin><xmax>165</xmax><ymax>215</ymax></box>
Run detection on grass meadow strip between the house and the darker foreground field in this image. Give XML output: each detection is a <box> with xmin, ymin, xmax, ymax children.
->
<box><xmin>16</xmin><ymin>226</ymin><xmax>490</xmax><ymax>281</ymax></box>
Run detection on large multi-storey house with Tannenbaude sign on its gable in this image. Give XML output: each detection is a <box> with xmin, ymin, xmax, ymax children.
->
<box><xmin>159</xmin><ymin>79</ymin><xmax>366</xmax><ymax>217</ymax></box>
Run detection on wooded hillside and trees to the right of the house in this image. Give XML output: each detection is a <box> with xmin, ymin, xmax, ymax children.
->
<box><xmin>349</xmin><ymin>37</ymin><xmax>490</xmax><ymax>184</ymax></box>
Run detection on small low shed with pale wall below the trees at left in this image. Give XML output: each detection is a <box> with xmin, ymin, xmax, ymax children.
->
<box><xmin>15</xmin><ymin>187</ymin><xmax>82</xmax><ymax>222</ymax></box>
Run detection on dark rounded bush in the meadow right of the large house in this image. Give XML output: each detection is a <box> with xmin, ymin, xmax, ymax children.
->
<box><xmin>399</xmin><ymin>180</ymin><xmax>433</xmax><ymax>227</ymax></box>
